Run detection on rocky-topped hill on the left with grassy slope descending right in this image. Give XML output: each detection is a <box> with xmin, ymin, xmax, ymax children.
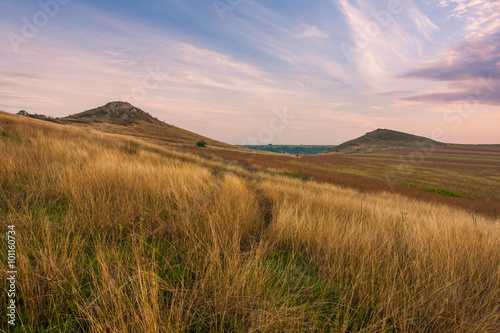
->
<box><xmin>60</xmin><ymin>102</ymin><xmax>236</xmax><ymax>149</ymax></box>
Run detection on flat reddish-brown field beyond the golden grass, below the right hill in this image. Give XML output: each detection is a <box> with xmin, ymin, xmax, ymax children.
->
<box><xmin>185</xmin><ymin>145</ymin><xmax>500</xmax><ymax>217</ymax></box>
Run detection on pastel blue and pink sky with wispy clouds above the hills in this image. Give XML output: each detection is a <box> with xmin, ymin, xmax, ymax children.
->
<box><xmin>0</xmin><ymin>0</ymin><xmax>500</xmax><ymax>145</ymax></box>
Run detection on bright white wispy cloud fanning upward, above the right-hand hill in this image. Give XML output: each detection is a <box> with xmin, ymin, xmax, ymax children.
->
<box><xmin>338</xmin><ymin>0</ymin><xmax>437</xmax><ymax>89</ymax></box>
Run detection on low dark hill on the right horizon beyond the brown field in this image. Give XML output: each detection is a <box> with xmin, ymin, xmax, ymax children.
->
<box><xmin>324</xmin><ymin>128</ymin><xmax>447</xmax><ymax>154</ymax></box>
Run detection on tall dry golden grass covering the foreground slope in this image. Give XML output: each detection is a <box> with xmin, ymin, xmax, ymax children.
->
<box><xmin>0</xmin><ymin>114</ymin><xmax>500</xmax><ymax>332</ymax></box>
